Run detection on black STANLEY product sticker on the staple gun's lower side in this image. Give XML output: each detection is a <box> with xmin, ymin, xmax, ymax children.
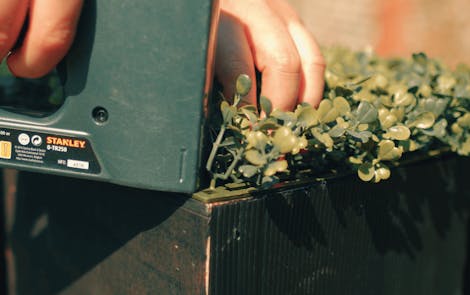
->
<box><xmin>0</xmin><ymin>128</ymin><xmax>101</xmax><ymax>174</ymax></box>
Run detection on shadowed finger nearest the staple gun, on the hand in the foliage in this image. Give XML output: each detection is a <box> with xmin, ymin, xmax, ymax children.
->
<box><xmin>215</xmin><ymin>10</ymin><xmax>256</xmax><ymax>105</ymax></box>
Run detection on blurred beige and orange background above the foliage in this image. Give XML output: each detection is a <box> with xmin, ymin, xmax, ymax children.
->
<box><xmin>288</xmin><ymin>0</ymin><xmax>470</xmax><ymax>66</ymax></box>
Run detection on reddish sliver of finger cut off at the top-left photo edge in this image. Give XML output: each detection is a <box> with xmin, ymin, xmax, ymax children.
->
<box><xmin>0</xmin><ymin>0</ymin><xmax>28</xmax><ymax>61</ymax></box>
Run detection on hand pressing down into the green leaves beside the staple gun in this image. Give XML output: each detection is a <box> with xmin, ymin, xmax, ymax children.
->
<box><xmin>215</xmin><ymin>0</ymin><xmax>325</xmax><ymax>110</ymax></box>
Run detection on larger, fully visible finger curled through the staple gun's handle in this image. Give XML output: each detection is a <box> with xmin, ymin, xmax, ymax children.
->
<box><xmin>7</xmin><ymin>0</ymin><xmax>83</xmax><ymax>78</ymax></box>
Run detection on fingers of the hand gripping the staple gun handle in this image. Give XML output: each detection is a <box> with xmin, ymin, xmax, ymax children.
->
<box><xmin>0</xmin><ymin>0</ymin><xmax>83</xmax><ymax>78</ymax></box>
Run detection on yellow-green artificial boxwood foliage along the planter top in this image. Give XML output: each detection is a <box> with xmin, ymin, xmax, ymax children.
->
<box><xmin>206</xmin><ymin>48</ymin><xmax>470</xmax><ymax>186</ymax></box>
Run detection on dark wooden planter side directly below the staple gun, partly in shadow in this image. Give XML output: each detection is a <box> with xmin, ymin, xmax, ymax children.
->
<box><xmin>9</xmin><ymin>172</ymin><xmax>208</xmax><ymax>294</ymax></box>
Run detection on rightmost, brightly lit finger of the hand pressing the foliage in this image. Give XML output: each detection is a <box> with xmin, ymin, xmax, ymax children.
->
<box><xmin>270</xmin><ymin>0</ymin><xmax>325</xmax><ymax>106</ymax></box>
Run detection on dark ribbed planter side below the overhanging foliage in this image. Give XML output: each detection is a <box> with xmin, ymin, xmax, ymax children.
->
<box><xmin>210</xmin><ymin>157</ymin><xmax>469</xmax><ymax>295</ymax></box>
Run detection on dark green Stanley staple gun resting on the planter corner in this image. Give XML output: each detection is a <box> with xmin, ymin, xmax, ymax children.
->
<box><xmin>0</xmin><ymin>0</ymin><xmax>218</xmax><ymax>193</ymax></box>
